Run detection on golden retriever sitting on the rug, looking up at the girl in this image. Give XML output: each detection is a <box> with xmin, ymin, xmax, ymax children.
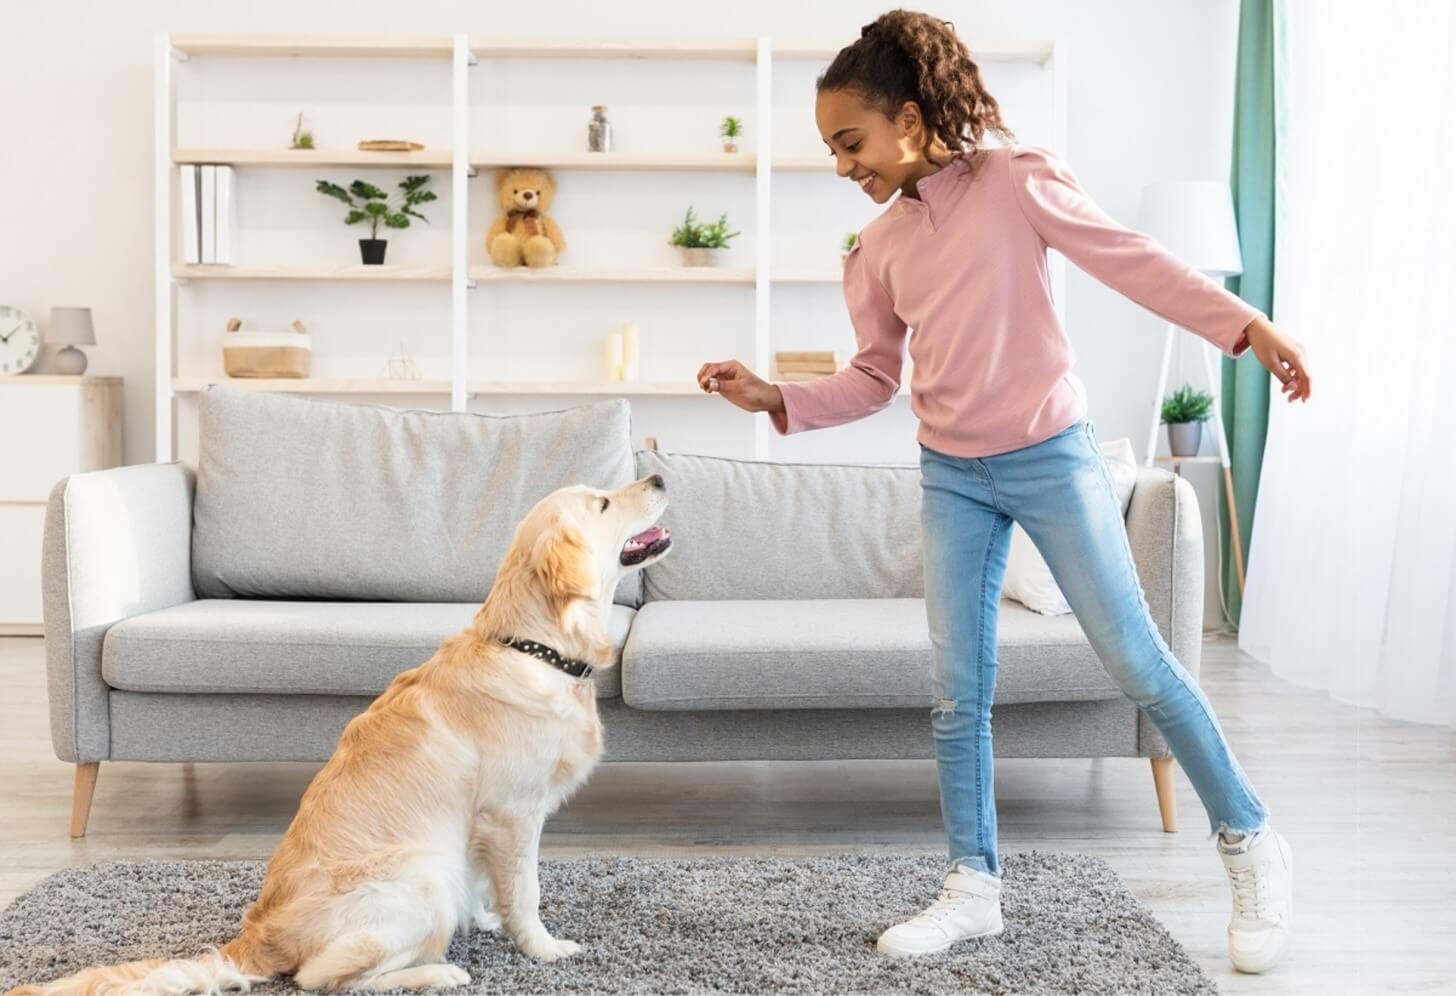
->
<box><xmin>12</xmin><ymin>475</ymin><xmax>671</xmax><ymax>996</ymax></box>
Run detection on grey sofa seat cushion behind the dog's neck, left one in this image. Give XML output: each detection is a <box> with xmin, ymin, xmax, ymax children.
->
<box><xmin>100</xmin><ymin>598</ymin><xmax>636</xmax><ymax>697</ymax></box>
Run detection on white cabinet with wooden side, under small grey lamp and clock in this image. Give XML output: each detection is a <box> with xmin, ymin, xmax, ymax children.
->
<box><xmin>0</xmin><ymin>374</ymin><xmax>121</xmax><ymax>635</ymax></box>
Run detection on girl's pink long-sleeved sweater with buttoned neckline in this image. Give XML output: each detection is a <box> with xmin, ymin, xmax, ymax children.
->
<box><xmin>769</xmin><ymin>146</ymin><xmax>1268</xmax><ymax>457</ymax></box>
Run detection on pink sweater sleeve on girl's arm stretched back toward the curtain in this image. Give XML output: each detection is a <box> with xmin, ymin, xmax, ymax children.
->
<box><xmin>1006</xmin><ymin>146</ymin><xmax>1268</xmax><ymax>357</ymax></box>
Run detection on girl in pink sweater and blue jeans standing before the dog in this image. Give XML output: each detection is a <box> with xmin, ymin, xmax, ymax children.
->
<box><xmin>697</xmin><ymin>10</ymin><xmax>1310</xmax><ymax>971</ymax></box>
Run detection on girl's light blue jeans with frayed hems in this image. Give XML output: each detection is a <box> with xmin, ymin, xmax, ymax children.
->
<box><xmin>920</xmin><ymin>418</ymin><xmax>1268</xmax><ymax>875</ymax></box>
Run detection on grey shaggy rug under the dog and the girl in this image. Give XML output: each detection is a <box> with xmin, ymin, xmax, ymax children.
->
<box><xmin>0</xmin><ymin>850</ymin><xmax>1217</xmax><ymax>993</ymax></box>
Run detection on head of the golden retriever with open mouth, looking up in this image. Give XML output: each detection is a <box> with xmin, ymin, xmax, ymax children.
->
<box><xmin>515</xmin><ymin>473</ymin><xmax>673</xmax><ymax>622</ymax></box>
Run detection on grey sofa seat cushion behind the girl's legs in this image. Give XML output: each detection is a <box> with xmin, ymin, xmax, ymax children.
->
<box><xmin>622</xmin><ymin>599</ymin><xmax>1123</xmax><ymax>711</ymax></box>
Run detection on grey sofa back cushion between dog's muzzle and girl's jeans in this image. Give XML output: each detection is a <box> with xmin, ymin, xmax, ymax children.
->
<box><xmin>636</xmin><ymin>450</ymin><xmax>925</xmax><ymax>601</ymax></box>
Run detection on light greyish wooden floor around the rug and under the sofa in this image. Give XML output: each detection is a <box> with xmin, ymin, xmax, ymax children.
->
<box><xmin>0</xmin><ymin>636</ymin><xmax>1456</xmax><ymax>996</ymax></box>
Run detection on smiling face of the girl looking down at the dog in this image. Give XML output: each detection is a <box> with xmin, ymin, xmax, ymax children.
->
<box><xmin>814</xmin><ymin>90</ymin><xmax>949</xmax><ymax>204</ymax></box>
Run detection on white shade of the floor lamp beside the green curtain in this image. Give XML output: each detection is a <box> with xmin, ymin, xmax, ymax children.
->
<box><xmin>1137</xmin><ymin>181</ymin><xmax>1243</xmax><ymax>277</ymax></box>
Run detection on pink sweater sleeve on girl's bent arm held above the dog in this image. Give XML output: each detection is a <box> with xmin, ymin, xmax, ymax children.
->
<box><xmin>769</xmin><ymin>239</ymin><xmax>906</xmax><ymax>435</ymax></box>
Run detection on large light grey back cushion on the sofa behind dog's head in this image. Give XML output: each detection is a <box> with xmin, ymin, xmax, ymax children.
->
<box><xmin>192</xmin><ymin>384</ymin><xmax>641</xmax><ymax>606</ymax></box>
